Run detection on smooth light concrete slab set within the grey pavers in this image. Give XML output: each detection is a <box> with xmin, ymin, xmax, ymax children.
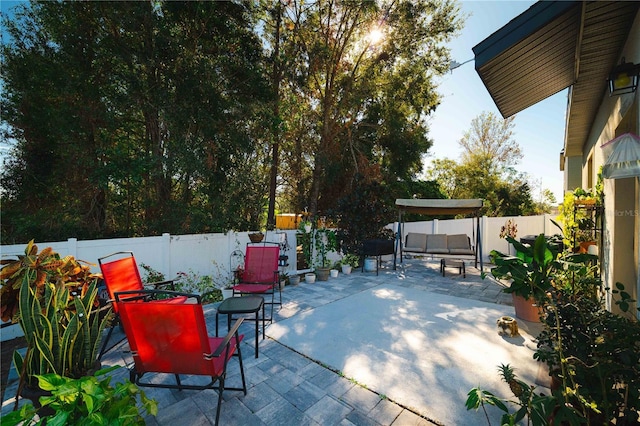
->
<box><xmin>267</xmin><ymin>283</ymin><xmax>538</xmax><ymax>425</ymax></box>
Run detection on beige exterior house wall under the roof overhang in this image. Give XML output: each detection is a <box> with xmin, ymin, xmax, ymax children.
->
<box><xmin>576</xmin><ymin>13</ymin><xmax>640</xmax><ymax>312</ymax></box>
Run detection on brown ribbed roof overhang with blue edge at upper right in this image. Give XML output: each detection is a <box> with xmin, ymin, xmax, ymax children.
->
<box><xmin>473</xmin><ymin>1</ymin><xmax>640</xmax><ymax>157</ymax></box>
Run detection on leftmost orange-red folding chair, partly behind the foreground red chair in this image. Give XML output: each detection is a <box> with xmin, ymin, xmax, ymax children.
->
<box><xmin>98</xmin><ymin>251</ymin><xmax>186</xmax><ymax>359</ymax></box>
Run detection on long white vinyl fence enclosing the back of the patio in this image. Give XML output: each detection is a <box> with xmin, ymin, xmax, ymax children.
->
<box><xmin>0</xmin><ymin>215</ymin><xmax>558</xmax><ymax>340</ymax></box>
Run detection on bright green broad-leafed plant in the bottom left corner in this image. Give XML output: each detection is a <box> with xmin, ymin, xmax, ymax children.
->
<box><xmin>0</xmin><ymin>365</ymin><xmax>158</xmax><ymax>425</ymax></box>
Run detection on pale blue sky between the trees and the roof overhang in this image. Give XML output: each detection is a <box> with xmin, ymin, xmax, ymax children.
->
<box><xmin>425</xmin><ymin>0</ymin><xmax>567</xmax><ymax>202</ymax></box>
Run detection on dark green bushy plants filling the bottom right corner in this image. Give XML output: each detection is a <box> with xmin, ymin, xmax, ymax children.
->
<box><xmin>466</xmin><ymin>278</ymin><xmax>640</xmax><ymax>425</ymax></box>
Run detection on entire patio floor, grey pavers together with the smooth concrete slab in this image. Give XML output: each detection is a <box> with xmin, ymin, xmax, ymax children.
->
<box><xmin>2</xmin><ymin>259</ymin><xmax>538</xmax><ymax>425</ymax></box>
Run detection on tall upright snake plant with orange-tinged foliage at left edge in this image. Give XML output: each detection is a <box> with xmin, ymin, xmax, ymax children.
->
<box><xmin>0</xmin><ymin>240</ymin><xmax>111</xmax><ymax>401</ymax></box>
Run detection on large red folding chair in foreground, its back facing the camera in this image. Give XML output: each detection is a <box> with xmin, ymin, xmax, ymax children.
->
<box><xmin>115</xmin><ymin>290</ymin><xmax>247</xmax><ymax>425</ymax></box>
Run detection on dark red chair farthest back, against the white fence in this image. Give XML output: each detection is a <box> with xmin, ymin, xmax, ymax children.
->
<box><xmin>233</xmin><ymin>243</ymin><xmax>282</xmax><ymax>321</ymax></box>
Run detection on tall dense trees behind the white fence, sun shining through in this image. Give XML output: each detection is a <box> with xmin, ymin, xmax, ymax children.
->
<box><xmin>1</xmin><ymin>0</ymin><xmax>462</xmax><ymax>243</ymax></box>
